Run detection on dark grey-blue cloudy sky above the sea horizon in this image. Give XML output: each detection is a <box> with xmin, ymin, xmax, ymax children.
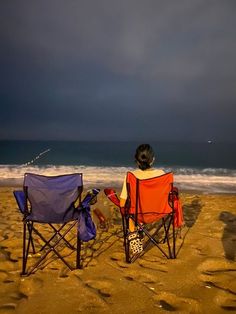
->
<box><xmin>0</xmin><ymin>0</ymin><xmax>236</xmax><ymax>141</ymax></box>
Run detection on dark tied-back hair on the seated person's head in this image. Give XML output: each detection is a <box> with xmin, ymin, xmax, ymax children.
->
<box><xmin>135</xmin><ymin>144</ymin><xmax>155</xmax><ymax>170</ymax></box>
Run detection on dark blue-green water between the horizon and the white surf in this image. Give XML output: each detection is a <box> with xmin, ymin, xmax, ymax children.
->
<box><xmin>0</xmin><ymin>141</ymin><xmax>236</xmax><ymax>169</ymax></box>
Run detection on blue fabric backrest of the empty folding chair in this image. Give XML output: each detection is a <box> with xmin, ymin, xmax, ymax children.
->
<box><xmin>23</xmin><ymin>173</ymin><xmax>83</xmax><ymax>223</ymax></box>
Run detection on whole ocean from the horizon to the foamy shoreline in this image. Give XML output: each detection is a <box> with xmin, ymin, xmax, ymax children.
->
<box><xmin>0</xmin><ymin>141</ymin><xmax>236</xmax><ymax>194</ymax></box>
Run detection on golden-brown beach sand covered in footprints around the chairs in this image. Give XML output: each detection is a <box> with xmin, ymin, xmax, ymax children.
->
<box><xmin>0</xmin><ymin>187</ymin><xmax>236</xmax><ymax>314</ymax></box>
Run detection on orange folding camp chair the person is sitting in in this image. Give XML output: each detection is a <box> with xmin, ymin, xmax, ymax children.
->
<box><xmin>104</xmin><ymin>172</ymin><xmax>183</xmax><ymax>263</ymax></box>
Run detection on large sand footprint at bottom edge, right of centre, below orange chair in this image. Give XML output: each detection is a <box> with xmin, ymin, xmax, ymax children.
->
<box><xmin>153</xmin><ymin>291</ymin><xmax>202</xmax><ymax>314</ymax></box>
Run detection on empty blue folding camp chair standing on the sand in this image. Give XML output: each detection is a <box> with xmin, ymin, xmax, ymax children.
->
<box><xmin>13</xmin><ymin>173</ymin><xmax>99</xmax><ymax>275</ymax></box>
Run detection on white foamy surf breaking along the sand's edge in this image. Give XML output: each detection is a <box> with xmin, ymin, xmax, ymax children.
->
<box><xmin>0</xmin><ymin>165</ymin><xmax>236</xmax><ymax>193</ymax></box>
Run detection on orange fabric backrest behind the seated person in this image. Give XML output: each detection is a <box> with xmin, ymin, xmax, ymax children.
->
<box><xmin>126</xmin><ymin>172</ymin><xmax>173</xmax><ymax>223</ymax></box>
